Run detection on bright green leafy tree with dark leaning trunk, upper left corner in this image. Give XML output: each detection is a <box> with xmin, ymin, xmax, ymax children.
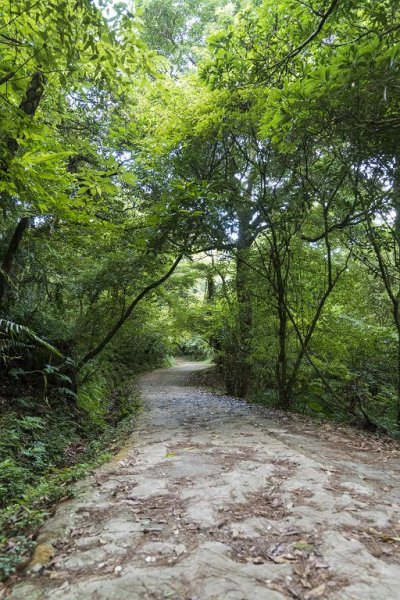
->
<box><xmin>0</xmin><ymin>0</ymin><xmax>152</xmax><ymax>302</ymax></box>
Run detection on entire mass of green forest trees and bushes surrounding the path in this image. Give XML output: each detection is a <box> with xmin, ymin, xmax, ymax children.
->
<box><xmin>0</xmin><ymin>0</ymin><xmax>400</xmax><ymax>572</ymax></box>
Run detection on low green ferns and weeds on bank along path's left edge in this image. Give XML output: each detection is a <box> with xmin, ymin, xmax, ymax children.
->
<box><xmin>0</xmin><ymin>371</ymin><xmax>140</xmax><ymax>580</ymax></box>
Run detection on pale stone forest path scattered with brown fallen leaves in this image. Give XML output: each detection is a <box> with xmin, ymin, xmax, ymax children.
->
<box><xmin>7</xmin><ymin>361</ymin><xmax>400</xmax><ymax>600</ymax></box>
